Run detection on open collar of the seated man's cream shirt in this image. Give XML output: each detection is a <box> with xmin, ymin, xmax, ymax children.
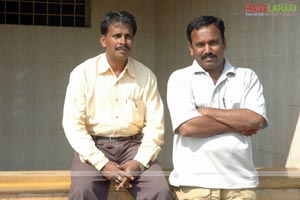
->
<box><xmin>97</xmin><ymin>53</ymin><xmax>135</xmax><ymax>78</ymax></box>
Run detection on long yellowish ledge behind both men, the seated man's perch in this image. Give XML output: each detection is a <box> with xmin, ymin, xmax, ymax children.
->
<box><xmin>0</xmin><ymin>168</ymin><xmax>300</xmax><ymax>195</ymax></box>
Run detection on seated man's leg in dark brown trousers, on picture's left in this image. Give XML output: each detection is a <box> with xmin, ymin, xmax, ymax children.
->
<box><xmin>69</xmin><ymin>154</ymin><xmax>110</xmax><ymax>200</ymax></box>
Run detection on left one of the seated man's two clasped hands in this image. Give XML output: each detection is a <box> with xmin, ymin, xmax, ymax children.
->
<box><xmin>101</xmin><ymin>161</ymin><xmax>134</xmax><ymax>190</ymax></box>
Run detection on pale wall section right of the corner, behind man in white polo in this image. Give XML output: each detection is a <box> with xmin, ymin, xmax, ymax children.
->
<box><xmin>155</xmin><ymin>0</ymin><xmax>300</xmax><ymax>167</ymax></box>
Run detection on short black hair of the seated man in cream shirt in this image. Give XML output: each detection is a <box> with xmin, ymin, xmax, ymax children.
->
<box><xmin>100</xmin><ymin>11</ymin><xmax>137</xmax><ymax>36</ymax></box>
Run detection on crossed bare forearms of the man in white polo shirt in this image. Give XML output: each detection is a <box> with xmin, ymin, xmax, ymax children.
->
<box><xmin>176</xmin><ymin>108</ymin><xmax>266</xmax><ymax>137</ymax></box>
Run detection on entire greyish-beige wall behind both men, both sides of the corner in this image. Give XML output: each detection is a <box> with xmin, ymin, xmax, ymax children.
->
<box><xmin>0</xmin><ymin>0</ymin><xmax>300</xmax><ymax>170</ymax></box>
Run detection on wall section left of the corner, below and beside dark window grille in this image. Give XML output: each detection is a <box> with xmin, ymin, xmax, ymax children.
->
<box><xmin>0</xmin><ymin>0</ymin><xmax>155</xmax><ymax>170</ymax></box>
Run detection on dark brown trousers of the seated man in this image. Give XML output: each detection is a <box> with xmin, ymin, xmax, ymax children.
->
<box><xmin>69</xmin><ymin>140</ymin><xmax>174</xmax><ymax>200</ymax></box>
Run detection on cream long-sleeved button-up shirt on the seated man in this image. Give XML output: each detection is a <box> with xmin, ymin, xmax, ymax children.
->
<box><xmin>63</xmin><ymin>53</ymin><xmax>164</xmax><ymax>170</ymax></box>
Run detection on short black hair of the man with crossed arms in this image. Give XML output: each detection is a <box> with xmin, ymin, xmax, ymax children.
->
<box><xmin>186</xmin><ymin>16</ymin><xmax>225</xmax><ymax>42</ymax></box>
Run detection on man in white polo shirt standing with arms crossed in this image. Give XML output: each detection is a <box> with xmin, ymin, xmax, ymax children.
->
<box><xmin>167</xmin><ymin>16</ymin><xmax>267</xmax><ymax>200</ymax></box>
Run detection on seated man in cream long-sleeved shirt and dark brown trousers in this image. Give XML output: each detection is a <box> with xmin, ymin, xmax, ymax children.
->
<box><xmin>63</xmin><ymin>11</ymin><xmax>173</xmax><ymax>200</ymax></box>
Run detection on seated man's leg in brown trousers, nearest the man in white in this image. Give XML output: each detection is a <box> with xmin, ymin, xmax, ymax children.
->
<box><xmin>128</xmin><ymin>162</ymin><xmax>174</xmax><ymax>200</ymax></box>
